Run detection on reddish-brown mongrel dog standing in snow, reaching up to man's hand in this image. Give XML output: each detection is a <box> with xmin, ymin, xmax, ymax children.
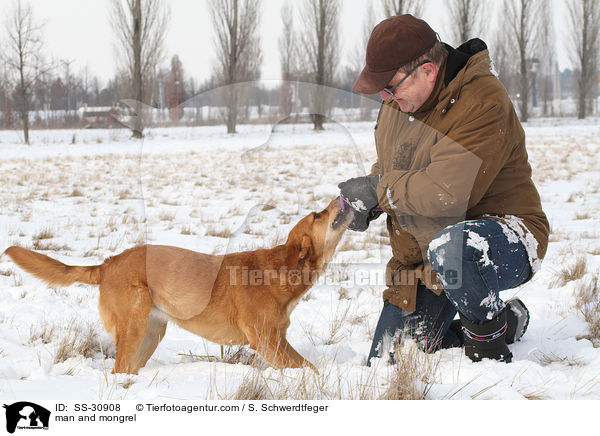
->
<box><xmin>5</xmin><ymin>200</ymin><xmax>352</xmax><ymax>374</ymax></box>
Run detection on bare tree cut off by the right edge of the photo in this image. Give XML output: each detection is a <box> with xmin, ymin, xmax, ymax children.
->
<box><xmin>568</xmin><ymin>0</ymin><xmax>600</xmax><ymax>119</ymax></box>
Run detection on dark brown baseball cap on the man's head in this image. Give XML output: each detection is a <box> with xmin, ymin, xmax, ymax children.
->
<box><xmin>352</xmin><ymin>14</ymin><xmax>438</xmax><ymax>94</ymax></box>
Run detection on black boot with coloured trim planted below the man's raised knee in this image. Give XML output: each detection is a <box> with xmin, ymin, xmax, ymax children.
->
<box><xmin>459</xmin><ymin>308</ymin><xmax>512</xmax><ymax>363</ymax></box>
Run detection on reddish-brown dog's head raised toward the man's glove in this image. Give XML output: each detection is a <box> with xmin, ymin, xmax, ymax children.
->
<box><xmin>286</xmin><ymin>198</ymin><xmax>353</xmax><ymax>270</ymax></box>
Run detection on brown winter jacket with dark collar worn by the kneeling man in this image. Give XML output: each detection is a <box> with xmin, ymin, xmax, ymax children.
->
<box><xmin>371</xmin><ymin>39</ymin><xmax>549</xmax><ymax>312</ymax></box>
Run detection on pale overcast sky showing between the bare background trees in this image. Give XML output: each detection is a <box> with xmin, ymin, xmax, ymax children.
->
<box><xmin>21</xmin><ymin>0</ymin><xmax>569</xmax><ymax>88</ymax></box>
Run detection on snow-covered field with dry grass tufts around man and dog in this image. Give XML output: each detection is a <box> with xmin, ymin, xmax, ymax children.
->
<box><xmin>0</xmin><ymin>119</ymin><xmax>600</xmax><ymax>402</ymax></box>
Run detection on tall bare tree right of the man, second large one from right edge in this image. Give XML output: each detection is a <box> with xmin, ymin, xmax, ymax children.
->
<box><xmin>504</xmin><ymin>0</ymin><xmax>540</xmax><ymax>122</ymax></box>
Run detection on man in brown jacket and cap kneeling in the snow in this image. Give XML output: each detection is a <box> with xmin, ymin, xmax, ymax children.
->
<box><xmin>339</xmin><ymin>15</ymin><xmax>549</xmax><ymax>364</ymax></box>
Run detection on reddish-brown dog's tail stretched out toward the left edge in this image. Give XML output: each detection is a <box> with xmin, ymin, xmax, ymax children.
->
<box><xmin>4</xmin><ymin>246</ymin><xmax>102</xmax><ymax>286</ymax></box>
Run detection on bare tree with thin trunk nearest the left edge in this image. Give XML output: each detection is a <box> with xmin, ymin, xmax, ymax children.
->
<box><xmin>2</xmin><ymin>0</ymin><xmax>47</xmax><ymax>144</ymax></box>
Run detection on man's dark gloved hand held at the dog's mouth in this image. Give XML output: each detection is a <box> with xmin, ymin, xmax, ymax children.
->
<box><xmin>338</xmin><ymin>175</ymin><xmax>381</xmax><ymax>232</ymax></box>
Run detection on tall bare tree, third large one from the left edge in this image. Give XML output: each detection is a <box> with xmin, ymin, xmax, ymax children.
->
<box><xmin>210</xmin><ymin>0</ymin><xmax>262</xmax><ymax>133</ymax></box>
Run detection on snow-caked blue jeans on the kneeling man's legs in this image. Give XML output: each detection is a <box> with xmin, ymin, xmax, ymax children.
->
<box><xmin>367</xmin><ymin>219</ymin><xmax>531</xmax><ymax>364</ymax></box>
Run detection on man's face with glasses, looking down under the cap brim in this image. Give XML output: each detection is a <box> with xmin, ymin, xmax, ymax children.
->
<box><xmin>379</xmin><ymin>62</ymin><xmax>439</xmax><ymax>112</ymax></box>
